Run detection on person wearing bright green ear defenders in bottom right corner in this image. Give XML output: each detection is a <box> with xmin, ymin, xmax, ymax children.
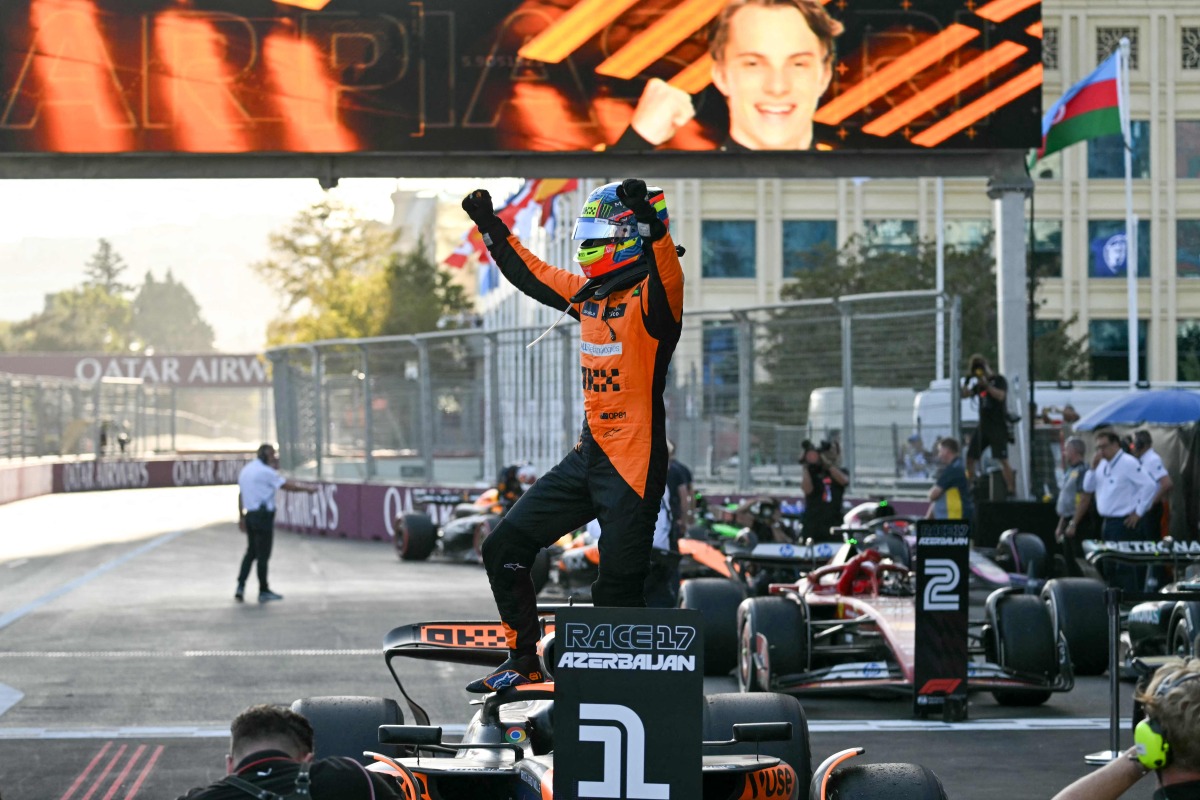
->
<box><xmin>1054</xmin><ymin>658</ymin><xmax>1200</xmax><ymax>800</ymax></box>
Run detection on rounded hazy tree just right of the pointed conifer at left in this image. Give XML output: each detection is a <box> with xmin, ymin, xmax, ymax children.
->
<box><xmin>132</xmin><ymin>270</ymin><xmax>214</xmax><ymax>353</ymax></box>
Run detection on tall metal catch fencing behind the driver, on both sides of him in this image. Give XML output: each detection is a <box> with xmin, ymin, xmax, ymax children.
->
<box><xmin>268</xmin><ymin>291</ymin><xmax>961</xmax><ymax>492</ymax></box>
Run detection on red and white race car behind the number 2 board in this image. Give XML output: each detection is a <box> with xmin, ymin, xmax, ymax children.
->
<box><xmin>736</xmin><ymin>549</ymin><xmax>1074</xmax><ymax>705</ymax></box>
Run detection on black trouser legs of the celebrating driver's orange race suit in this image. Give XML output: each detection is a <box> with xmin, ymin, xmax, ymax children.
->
<box><xmin>482</xmin><ymin>427</ymin><xmax>667</xmax><ymax>655</ymax></box>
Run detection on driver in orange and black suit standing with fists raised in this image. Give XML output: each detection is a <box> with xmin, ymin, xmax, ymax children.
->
<box><xmin>462</xmin><ymin>178</ymin><xmax>683</xmax><ymax>692</ymax></box>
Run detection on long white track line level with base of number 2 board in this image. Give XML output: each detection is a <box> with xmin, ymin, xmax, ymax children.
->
<box><xmin>0</xmin><ymin>717</ymin><xmax>1129</xmax><ymax>740</ymax></box>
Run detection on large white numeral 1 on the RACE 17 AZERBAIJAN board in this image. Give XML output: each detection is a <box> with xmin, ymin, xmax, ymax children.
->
<box><xmin>580</xmin><ymin>703</ymin><xmax>671</xmax><ymax>800</ymax></box>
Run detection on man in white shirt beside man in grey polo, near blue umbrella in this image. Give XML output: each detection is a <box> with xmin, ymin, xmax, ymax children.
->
<box><xmin>1067</xmin><ymin>431</ymin><xmax>1157</xmax><ymax>591</ymax></box>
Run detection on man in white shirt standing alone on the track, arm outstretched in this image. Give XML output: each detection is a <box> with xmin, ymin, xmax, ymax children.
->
<box><xmin>233</xmin><ymin>445</ymin><xmax>317</xmax><ymax>603</ymax></box>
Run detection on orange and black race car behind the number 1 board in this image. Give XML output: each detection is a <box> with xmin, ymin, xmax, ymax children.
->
<box><xmin>293</xmin><ymin>608</ymin><xmax>944</xmax><ymax>800</ymax></box>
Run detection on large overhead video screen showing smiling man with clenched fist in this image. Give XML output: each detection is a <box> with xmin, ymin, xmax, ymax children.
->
<box><xmin>0</xmin><ymin>0</ymin><xmax>1042</xmax><ymax>154</ymax></box>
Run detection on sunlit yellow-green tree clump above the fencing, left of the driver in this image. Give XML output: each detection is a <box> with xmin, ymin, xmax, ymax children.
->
<box><xmin>253</xmin><ymin>200</ymin><xmax>470</xmax><ymax>344</ymax></box>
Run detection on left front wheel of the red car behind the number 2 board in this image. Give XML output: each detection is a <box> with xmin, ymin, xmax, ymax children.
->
<box><xmin>738</xmin><ymin>597</ymin><xmax>809</xmax><ymax>692</ymax></box>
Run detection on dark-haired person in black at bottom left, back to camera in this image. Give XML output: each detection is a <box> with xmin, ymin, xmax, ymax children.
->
<box><xmin>179</xmin><ymin>704</ymin><xmax>408</xmax><ymax>800</ymax></box>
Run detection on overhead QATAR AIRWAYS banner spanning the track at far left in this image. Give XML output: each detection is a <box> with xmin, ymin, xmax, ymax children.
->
<box><xmin>0</xmin><ymin>353</ymin><xmax>271</xmax><ymax>389</ymax></box>
